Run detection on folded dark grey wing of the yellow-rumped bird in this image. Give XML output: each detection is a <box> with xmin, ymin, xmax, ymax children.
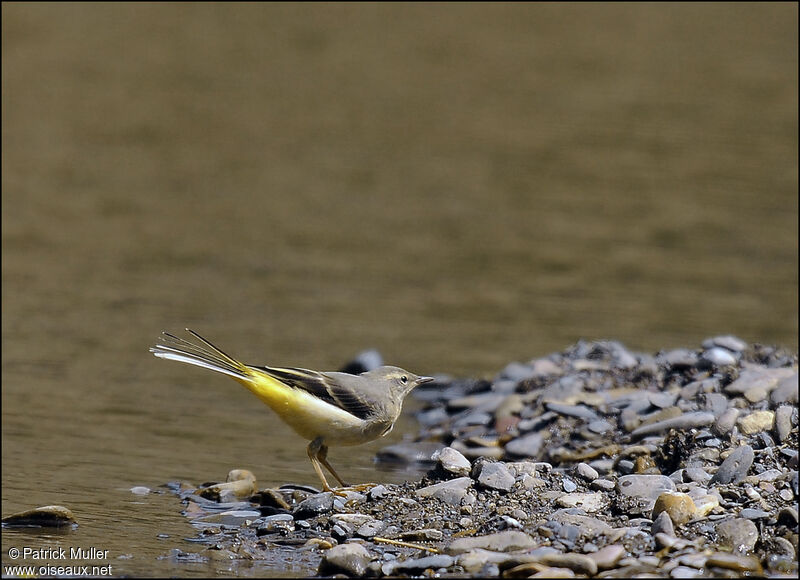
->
<box><xmin>253</xmin><ymin>367</ymin><xmax>375</xmax><ymax>420</ymax></box>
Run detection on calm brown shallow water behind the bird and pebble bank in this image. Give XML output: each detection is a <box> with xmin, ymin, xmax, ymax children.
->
<box><xmin>2</xmin><ymin>4</ymin><xmax>798</xmax><ymax>576</ymax></box>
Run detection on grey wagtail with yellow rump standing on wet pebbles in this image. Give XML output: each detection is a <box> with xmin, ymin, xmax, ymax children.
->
<box><xmin>150</xmin><ymin>328</ymin><xmax>433</xmax><ymax>491</ymax></box>
